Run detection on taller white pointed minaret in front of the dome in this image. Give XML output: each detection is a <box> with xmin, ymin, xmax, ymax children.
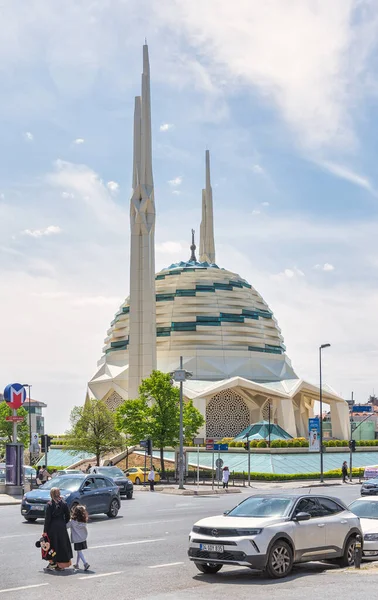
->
<box><xmin>128</xmin><ymin>43</ymin><xmax>156</xmax><ymax>399</ymax></box>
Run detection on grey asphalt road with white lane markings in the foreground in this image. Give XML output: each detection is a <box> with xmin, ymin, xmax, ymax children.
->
<box><xmin>0</xmin><ymin>485</ymin><xmax>378</xmax><ymax>600</ymax></box>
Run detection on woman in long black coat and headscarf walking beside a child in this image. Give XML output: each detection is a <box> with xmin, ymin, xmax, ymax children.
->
<box><xmin>43</xmin><ymin>488</ymin><xmax>72</xmax><ymax>570</ymax></box>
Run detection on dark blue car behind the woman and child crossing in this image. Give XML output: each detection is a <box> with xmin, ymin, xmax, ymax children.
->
<box><xmin>21</xmin><ymin>473</ymin><xmax>121</xmax><ymax>521</ymax></box>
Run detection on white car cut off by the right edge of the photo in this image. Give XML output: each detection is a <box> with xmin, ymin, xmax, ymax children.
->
<box><xmin>348</xmin><ymin>496</ymin><xmax>378</xmax><ymax>560</ymax></box>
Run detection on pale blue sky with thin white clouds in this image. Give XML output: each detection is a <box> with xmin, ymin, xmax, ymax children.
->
<box><xmin>0</xmin><ymin>0</ymin><xmax>378</xmax><ymax>434</ymax></box>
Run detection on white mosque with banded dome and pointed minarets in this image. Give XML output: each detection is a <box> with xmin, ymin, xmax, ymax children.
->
<box><xmin>87</xmin><ymin>45</ymin><xmax>350</xmax><ymax>439</ymax></box>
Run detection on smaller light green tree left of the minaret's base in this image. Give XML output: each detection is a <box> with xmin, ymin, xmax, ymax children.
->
<box><xmin>67</xmin><ymin>398</ymin><xmax>122</xmax><ymax>466</ymax></box>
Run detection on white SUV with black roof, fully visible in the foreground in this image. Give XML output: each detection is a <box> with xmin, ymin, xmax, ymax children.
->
<box><xmin>188</xmin><ymin>495</ymin><xmax>362</xmax><ymax>578</ymax></box>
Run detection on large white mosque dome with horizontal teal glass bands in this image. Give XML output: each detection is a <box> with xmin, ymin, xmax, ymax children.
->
<box><xmin>99</xmin><ymin>261</ymin><xmax>296</xmax><ymax>382</ymax></box>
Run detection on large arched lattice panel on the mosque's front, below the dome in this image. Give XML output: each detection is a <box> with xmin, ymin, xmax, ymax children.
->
<box><xmin>206</xmin><ymin>390</ymin><xmax>250</xmax><ymax>438</ymax></box>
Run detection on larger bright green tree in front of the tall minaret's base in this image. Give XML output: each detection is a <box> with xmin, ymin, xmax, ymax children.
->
<box><xmin>116</xmin><ymin>371</ymin><xmax>204</xmax><ymax>474</ymax></box>
